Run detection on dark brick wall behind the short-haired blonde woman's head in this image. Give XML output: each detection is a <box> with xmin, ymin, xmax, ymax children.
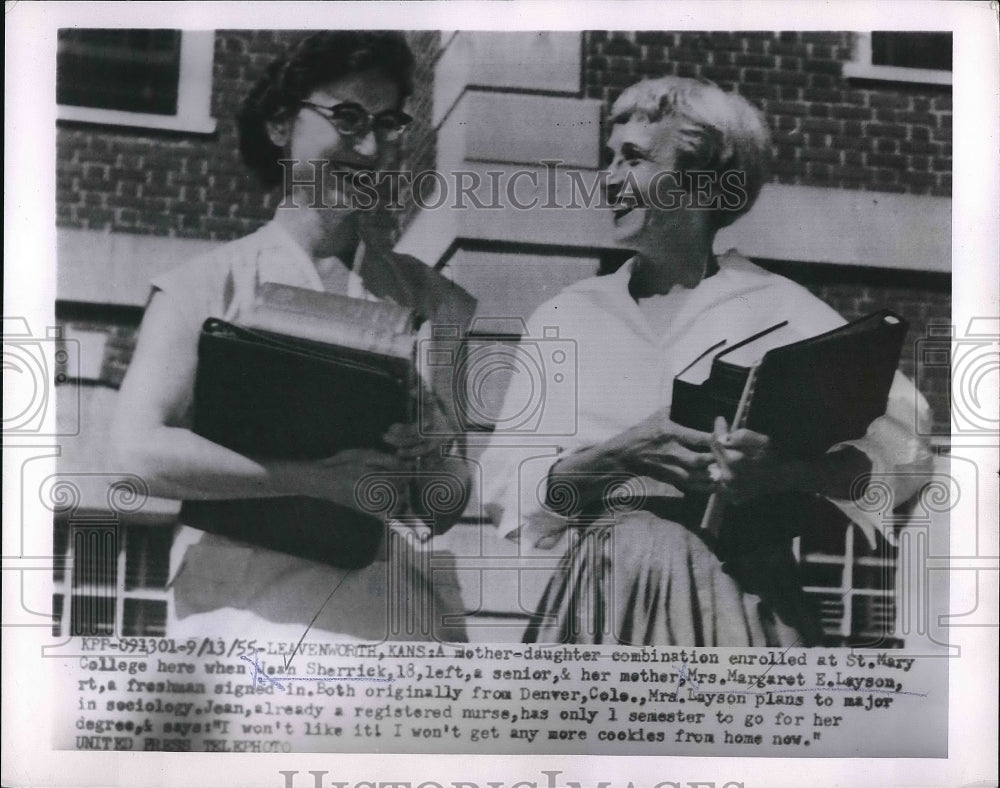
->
<box><xmin>584</xmin><ymin>31</ymin><xmax>952</xmax><ymax>196</ymax></box>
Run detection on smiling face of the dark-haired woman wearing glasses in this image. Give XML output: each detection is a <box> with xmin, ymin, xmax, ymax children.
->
<box><xmin>268</xmin><ymin>72</ymin><xmax>400</xmax><ymax>207</ymax></box>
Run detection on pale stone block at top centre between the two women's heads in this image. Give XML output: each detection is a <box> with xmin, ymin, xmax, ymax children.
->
<box><xmin>433</xmin><ymin>30</ymin><xmax>583</xmax><ymax>126</ymax></box>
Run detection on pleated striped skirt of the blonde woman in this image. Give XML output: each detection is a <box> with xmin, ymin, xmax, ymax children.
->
<box><xmin>525</xmin><ymin>511</ymin><xmax>819</xmax><ymax>647</ymax></box>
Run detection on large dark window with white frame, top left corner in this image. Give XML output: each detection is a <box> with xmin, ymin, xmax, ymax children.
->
<box><xmin>56</xmin><ymin>28</ymin><xmax>215</xmax><ymax>133</ymax></box>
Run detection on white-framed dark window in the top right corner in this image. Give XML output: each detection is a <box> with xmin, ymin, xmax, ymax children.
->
<box><xmin>844</xmin><ymin>31</ymin><xmax>952</xmax><ymax>85</ymax></box>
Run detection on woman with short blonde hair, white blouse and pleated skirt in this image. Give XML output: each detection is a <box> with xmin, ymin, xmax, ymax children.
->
<box><xmin>483</xmin><ymin>78</ymin><xmax>928</xmax><ymax>646</ymax></box>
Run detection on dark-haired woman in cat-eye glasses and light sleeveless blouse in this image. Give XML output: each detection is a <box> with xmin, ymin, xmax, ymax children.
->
<box><xmin>114</xmin><ymin>31</ymin><xmax>474</xmax><ymax>640</ymax></box>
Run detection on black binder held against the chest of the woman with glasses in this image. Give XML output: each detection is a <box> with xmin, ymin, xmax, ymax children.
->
<box><xmin>194</xmin><ymin>318</ymin><xmax>415</xmax><ymax>460</ymax></box>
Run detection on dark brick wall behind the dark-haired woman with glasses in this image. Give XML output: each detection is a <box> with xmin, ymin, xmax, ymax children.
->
<box><xmin>56</xmin><ymin>30</ymin><xmax>439</xmax><ymax>241</ymax></box>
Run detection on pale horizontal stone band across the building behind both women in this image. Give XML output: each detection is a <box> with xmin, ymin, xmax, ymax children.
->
<box><xmin>56</xmin><ymin>182</ymin><xmax>952</xmax><ymax>306</ymax></box>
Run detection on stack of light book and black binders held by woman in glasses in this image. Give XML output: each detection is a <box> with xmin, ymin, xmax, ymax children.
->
<box><xmin>181</xmin><ymin>284</ymin><xmax>430</xmax><ymax>568</ymax></box>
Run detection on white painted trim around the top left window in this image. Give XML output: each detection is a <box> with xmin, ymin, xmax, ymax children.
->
<box><xmin>56</xmin><ymin>30</ymin><xmax>215</xmax><ymax>134</ymax></box>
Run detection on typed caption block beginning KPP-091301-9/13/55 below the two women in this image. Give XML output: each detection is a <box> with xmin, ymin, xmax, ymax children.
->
<box><xmin>52</xmin><ymin>638</ymin><xmax>948</xmax><ymax>757</ymax></box>
